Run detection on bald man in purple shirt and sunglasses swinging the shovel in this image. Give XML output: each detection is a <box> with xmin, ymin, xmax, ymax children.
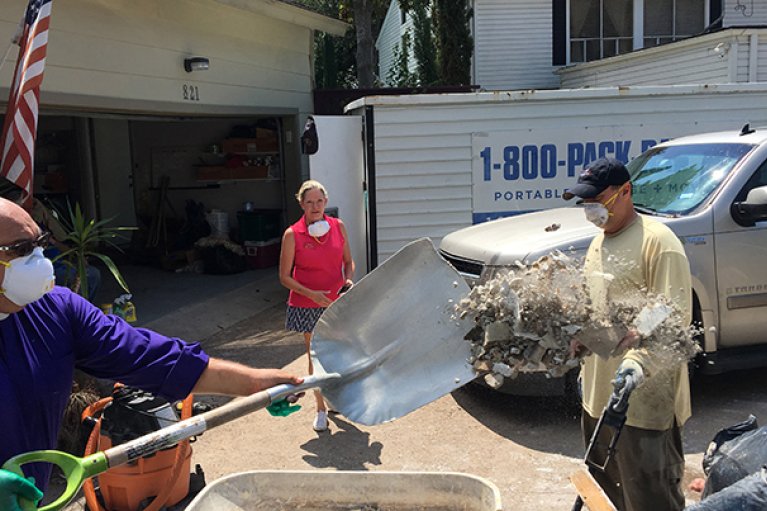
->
<box><xmin>0</xmin><ymin>199</ymin><xmax>303</xmax><ymax>510</ymax></box>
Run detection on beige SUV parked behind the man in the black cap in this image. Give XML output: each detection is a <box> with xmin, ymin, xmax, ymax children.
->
<box><xmin>439</xmin><ymin>125</ymin><xmax>767</xmax><ymax>395</ymax></box>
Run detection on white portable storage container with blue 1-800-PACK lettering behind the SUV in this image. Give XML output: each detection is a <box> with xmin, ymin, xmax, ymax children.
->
<box><xmin>310</xmin><ymin>83</ymin><xmax>767</xmax><ymax>275</ymax></box>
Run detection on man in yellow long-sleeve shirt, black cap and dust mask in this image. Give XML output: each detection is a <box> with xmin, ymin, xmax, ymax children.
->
<box><xmin>564</xmin><ymin>158</ymin><xmax>692</xmax><ymax>511</ymax></box>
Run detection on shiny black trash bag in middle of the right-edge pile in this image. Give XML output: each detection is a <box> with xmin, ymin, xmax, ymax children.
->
<box><xmin>701</xmin><ymin>415</ymin><xmax>767</xmax><ymax>499</ymax></box>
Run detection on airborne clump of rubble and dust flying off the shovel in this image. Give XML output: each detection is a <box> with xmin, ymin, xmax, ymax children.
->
<box><xmin>455</xmin><ymin>252</ymin><xmax>699</xmax><ymax>388</ymax></box>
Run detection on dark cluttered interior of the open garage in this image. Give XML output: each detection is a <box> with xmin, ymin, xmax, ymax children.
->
<box><xmin>34</xmin><ymin>113</ymin><xmax>300</xmax><ymax>323</ymax></box>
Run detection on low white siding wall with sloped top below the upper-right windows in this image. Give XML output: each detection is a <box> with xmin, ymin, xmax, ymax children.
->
<box><xmin>560</xmin><ymin>29</ymin><xmax>767</xmax><ymax>88</ymax></box>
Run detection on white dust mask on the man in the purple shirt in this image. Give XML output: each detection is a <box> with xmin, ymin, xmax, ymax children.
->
<box><xmin>0</xmin><ymin>247</ymin><xmax>56</xmax><ymax>307</ymax></box>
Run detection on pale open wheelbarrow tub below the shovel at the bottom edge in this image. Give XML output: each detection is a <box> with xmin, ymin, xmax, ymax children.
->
<box><xmin>186</xmin><ymin>470</ymin><xmax>501</xmax><ymax>511</ymax></box>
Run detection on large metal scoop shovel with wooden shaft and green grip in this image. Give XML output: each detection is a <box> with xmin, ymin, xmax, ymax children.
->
<box><xmin>3</xmin><ymin>238</ymin><xmax>477</xmax><ymax>511</ymax></box>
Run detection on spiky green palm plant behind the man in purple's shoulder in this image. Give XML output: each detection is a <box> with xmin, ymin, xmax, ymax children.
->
<box><xmin>53</xmin><ymin>203</ymin><xmax>134</xmax><ymax>299</ymax></box>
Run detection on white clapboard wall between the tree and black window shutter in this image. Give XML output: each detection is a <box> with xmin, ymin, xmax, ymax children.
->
<box><xmin>474</xmin><ymin>0</ymin><xmax>559</xmax><ymax>90</ymax></box>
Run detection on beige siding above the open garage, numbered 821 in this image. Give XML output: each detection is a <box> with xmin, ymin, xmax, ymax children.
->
<box><xmin>0</xmin><ymin>0</ymin><xmax>320</xmax><ymax>113</ymax></box>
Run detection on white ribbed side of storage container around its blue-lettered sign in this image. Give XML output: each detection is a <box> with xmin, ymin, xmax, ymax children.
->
<box><xmin>350</xmin><ymin>85</ymin><xmax>767</xmax><ymax>263</ymax></box>
